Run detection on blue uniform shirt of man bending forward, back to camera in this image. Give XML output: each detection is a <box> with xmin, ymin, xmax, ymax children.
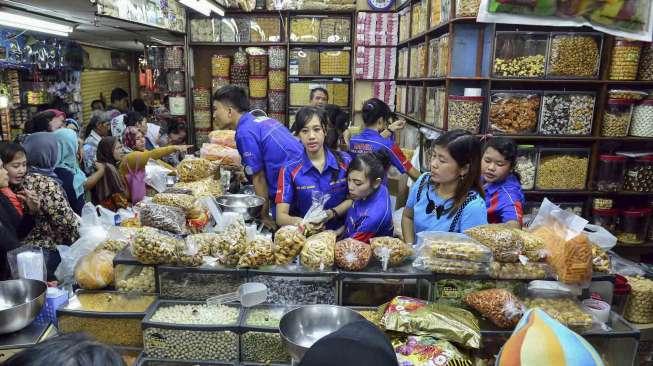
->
<box><xmin>236</xmin><ymin>113</ymin><xmax>304</xmax><ymax>200</ymax></box>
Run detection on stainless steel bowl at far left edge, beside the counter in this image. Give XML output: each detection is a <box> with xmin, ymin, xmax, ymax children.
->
<box><xmin>0</xmin><ymin>279</ymin><xmax>47</xmax><ymax>334</ymax></box>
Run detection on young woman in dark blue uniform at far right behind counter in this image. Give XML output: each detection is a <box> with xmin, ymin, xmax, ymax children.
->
<box><xmin>481</xmin><ymin>137</ymin><xmax>524</xmax><ymax>228</ymax></box>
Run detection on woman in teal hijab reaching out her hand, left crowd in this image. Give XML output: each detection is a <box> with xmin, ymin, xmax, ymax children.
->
<box><xmin>54</xmin><ymin>128</ymin><xmax>104</xmax><ymax>215</ymax></box>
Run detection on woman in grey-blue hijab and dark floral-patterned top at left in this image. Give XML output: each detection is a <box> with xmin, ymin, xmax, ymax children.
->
<box><xmin>20</xmin><ymin>132</ymin><xmax>79</xmax><ymax>280</ymax></box>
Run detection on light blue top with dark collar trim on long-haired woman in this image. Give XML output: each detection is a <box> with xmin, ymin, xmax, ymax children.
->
<box><xmin>406</xmin><ymin>173</ymin><xmax>487</xmax><ymax>234</ymax></box>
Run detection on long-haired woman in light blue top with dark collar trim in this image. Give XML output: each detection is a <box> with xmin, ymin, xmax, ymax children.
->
<box><xmin>401</xmin><ymin>130</ymin><xmax>487</xmax><ymax>244</ymax></box>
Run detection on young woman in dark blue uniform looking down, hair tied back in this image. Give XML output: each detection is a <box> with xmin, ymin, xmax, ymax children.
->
<box><xmin>345</xmin><ymin>151</ymin><xmax>393</xmax><ymax>243</ymax></box>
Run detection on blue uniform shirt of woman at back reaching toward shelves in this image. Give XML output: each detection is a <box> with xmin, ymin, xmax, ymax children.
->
<box><xmin>349</xmin><ymin>128</ymin><xmax>413</xmax><ymax>174</ymax></box>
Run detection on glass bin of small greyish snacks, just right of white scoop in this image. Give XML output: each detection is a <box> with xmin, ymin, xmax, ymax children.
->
<box><xmin>248</xmin><ymin>265</ymin><xmax>338</xmax><ymax>305</ymax></box>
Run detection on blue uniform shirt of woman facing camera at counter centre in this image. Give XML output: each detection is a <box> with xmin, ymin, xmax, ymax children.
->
<box><xmin>275</xmin><ymin>149</ymin><xmax>351</xmax><ymax>230</ymax></box>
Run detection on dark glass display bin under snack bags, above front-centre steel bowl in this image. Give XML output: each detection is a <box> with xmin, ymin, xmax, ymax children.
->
<box><xmin>339</xmin><ymin>261</ymin><xmax>433</xmax><ymax>306</ymax></box>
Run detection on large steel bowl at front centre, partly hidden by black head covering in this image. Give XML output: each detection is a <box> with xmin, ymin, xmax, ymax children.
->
<box><xmin>279</xmin><ymin>305</ymin><xmax>365</xmax><ymax>362</ymax></box>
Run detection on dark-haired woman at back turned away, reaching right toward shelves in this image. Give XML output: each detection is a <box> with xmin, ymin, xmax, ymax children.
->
<box><xmin>349</xmin><ymin>98</ymin><xmax>420</xmax><ymax>180</ymax></box>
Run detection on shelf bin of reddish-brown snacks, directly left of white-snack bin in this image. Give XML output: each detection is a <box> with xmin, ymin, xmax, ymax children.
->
<box><xmin>488</xmin><ymin>91</ymin><xmax>542</xmax><ymax>135</ymax></box>
